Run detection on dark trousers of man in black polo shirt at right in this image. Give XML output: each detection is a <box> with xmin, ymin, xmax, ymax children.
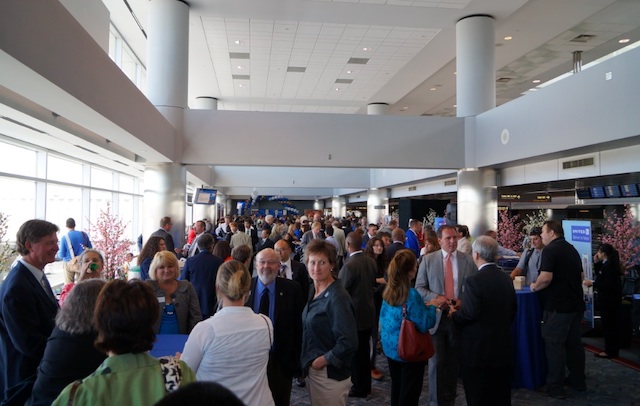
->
<box><xmin>542</xmin><ymin>311</ymin><xmax>585</xmax><ymax>393</ymax></box>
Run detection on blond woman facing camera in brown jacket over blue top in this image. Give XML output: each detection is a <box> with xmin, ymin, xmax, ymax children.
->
<box><xmin>146</xmin><ymin>251</ymin><xmax>202</xmax><ymax>334</ymax></box>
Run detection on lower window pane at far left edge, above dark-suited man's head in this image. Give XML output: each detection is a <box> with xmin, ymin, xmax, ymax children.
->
<box><xmin>0</xmin><ymin>177</ymin><xmax>36</xmax><ymax>241</ymax></box>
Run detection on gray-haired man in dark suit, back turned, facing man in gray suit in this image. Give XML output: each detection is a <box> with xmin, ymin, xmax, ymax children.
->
<box><xmin>449</xmin><ymin>236</ymin><xmax>516</xmax><ymax>406</ymax></box>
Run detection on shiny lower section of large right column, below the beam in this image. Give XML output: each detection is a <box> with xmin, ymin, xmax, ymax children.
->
<box><xmin>458</xmin><ymin>169</ymin><xmax>498</xmax><ymax>237</ymax></box>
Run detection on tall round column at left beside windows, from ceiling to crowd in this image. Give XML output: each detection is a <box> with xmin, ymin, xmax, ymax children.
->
<box><xmin>142</xmin><ymin>0</ymin><xmax>189</xmax><ymax>246</ymax></box>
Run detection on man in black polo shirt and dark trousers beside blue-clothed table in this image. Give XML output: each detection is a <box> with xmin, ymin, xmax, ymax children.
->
<box><xmin>531</xmin><ymin>220</ymin><xmax>587</xmax><ymax>399</ymax></box>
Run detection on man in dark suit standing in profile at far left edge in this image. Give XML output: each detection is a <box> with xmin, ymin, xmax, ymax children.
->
<box><xmin>0</xmin><ymin>220</ymin><xmax>59</xmax><ymax>405</ymax></box>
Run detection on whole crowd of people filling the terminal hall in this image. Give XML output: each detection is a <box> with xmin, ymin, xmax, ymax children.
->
<box><xmin>0</xmin><ymin>213</ymin><xmax>620</xmax><ymax>406</ymax></box>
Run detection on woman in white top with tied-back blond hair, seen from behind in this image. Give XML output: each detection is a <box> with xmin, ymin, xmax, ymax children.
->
<box><xmin>181</xmin><ymin>260</ymin><xmax>274</xmax><ymax>406</ymax></box>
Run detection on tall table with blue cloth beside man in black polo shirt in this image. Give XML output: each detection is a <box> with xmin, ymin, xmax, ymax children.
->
<box><xmin>511</xmin><ymin>286</ymin><xmax>547</xmax><ymax>389</ymax></box>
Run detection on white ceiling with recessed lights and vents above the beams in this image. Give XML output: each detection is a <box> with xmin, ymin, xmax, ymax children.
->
<box><xmin>104</xmin><ymin>0</ymin><xmax>640</xmax><ymax>116</ymax></box>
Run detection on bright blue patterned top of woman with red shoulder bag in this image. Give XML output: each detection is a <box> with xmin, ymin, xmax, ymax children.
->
<box><xmin>380</xmin><ymin>288</ymin><xmax>436</xmax><ymax>362</ymax></box>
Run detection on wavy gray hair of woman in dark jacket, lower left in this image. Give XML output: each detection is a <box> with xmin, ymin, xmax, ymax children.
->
<box><xmin>56</xmin><ymin>279</ymin><xmax>107</xmax><ymax>335</ymax></box>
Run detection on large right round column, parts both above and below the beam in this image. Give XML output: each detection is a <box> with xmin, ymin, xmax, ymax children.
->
<box><xmin>456</xmin><ymin>15</ymin><xmax>498</xmax><ymax>237</ymax></box>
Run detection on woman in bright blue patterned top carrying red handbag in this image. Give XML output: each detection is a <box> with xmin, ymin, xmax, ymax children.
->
<box><xmin>380</xmin><ymin>249</ymin><xmax>436</xmax><ymax>406</ymax></box>
